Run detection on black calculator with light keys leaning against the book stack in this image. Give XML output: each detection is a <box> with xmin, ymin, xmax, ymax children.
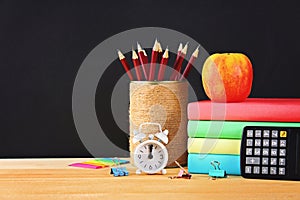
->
<box><xmin>240</xmin><ymin>126</ymin><xmax>300</xmax><ymax>180</ymax></box>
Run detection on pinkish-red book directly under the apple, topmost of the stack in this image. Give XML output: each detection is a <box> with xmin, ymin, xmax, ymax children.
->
<box><xmin>188</xmin><ymin>98</ymin><xmax>300</xmax><ymax>122</ymax></box>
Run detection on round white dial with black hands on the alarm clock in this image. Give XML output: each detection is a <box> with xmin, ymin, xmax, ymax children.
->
<box><xmin>134</xmin><ymin>140</ymin><xmax>168</xmax><ymax>174</ymax></box>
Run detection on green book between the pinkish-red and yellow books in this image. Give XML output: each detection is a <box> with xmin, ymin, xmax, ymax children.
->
<box><xmin>188</xmin><ymin>121</ymin><xmax>300</xmax><ymax>139</ymax></box>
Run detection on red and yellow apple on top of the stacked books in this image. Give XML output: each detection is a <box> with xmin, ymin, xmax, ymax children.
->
<box><xmin>202</xmin><ymin>53</ymin><xmax>253</xmax><ymax>102</ymax></box>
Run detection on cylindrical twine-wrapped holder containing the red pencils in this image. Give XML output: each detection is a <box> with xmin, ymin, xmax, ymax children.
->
<box><xmin>129</xmin><ymin>81</ymin><xmax>188</xmax><ymax>167</ymax></box>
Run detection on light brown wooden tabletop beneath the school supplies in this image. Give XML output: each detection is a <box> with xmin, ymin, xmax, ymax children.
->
<box><xmin>0</xmin><ymin>158</ymin><xmax>300</xmax><ymax>200</ymax></box>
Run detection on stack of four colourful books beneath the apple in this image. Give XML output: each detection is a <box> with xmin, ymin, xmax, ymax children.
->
<box><xmin>188</xmin><ymin>98</ymin><xmax>300</xmax><ymax>175</ymax></box>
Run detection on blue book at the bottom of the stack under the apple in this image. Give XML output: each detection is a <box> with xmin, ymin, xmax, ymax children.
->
<box><xmin>188</xmin><ymin>153</ymin><xmax>241</xmax><ymax>175</ymax></box>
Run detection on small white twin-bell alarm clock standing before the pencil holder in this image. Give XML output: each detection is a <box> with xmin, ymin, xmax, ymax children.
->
<box><xmin>133</xmin><ymin>122</ymin><xmax>168</xmax><ymax>174</ymax></box>
